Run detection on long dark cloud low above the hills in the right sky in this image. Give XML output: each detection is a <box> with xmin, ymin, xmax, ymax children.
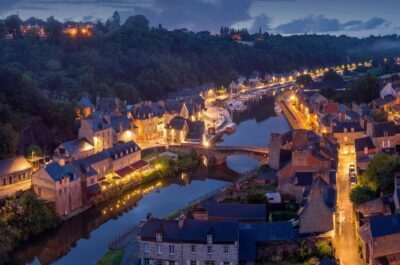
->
<box><xmin>275</xmin><ymin>15</ymin><xmax>389</xmax><ymax>34</ymax></box>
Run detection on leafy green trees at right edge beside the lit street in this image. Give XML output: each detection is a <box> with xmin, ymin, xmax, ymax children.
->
<box><xmin>362</xmin><ymin>153</ymin><xmax>400</xmax><ymax>194</ymax></box>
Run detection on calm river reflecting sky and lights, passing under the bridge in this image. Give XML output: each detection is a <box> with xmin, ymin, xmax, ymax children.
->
<box><xmin>13</xmin><ymin>94</ymin><xmax>289</xmax><ymax>265</ymax></box>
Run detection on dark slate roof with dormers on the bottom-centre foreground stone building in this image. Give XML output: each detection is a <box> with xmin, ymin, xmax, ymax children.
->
<box><xmin>139</xmin><ymin>219</ymin><xmax>239</xmax><ymax>244</ymax></box>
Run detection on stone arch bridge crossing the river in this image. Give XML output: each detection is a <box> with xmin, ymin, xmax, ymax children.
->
<box><xmin>169</xmin><ymin>144</ymin><xmax>269</xmax><ymax>166</ymax></box>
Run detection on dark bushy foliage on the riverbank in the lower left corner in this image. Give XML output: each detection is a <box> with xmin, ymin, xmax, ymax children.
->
<box><xmin>0</xmin><ymin>191</ymin><xmax>59</xmax><ymax>256</ymax></box>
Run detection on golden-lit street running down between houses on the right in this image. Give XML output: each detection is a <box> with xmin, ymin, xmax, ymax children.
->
<box><xmin>334</xmin><ymin>146</ymin><xmax>365</xmax><ymax>265</ymax></box>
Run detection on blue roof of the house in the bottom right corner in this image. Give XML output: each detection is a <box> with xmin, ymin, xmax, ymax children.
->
<box><xmin>369</xmin><ymin>214</ymin><xmax>400</xmax><ymax>237</ymax></box>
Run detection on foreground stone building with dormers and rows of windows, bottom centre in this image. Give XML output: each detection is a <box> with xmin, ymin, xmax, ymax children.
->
<box><xmin>138</xmin><ymin>216</ymin><xmax>239</xmax><ymax>265</ymax></box>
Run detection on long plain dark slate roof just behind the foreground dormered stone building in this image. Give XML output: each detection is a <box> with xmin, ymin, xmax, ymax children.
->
<box><xmin>202</xmin><ymin>203</ymin><xmax>267</xmax><ymax>220</ymax></box>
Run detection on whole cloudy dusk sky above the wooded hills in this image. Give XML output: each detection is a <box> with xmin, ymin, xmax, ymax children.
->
<box><xmin>0</xmin><ymin>0</ymin><xmax>400</xmax><ymax>37</ymax></box>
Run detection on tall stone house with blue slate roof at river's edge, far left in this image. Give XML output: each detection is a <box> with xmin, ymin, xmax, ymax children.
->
<box><xmin>32</xmin><ymin>162</ymin><xmax>83</xmax><ymax>216</ymax></box>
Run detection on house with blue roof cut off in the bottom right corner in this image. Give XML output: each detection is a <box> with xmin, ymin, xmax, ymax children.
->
<box><xmin>358</xmin><ymin>214</ymin><xmax>400</xmax><ymax>265</ymax></box>
